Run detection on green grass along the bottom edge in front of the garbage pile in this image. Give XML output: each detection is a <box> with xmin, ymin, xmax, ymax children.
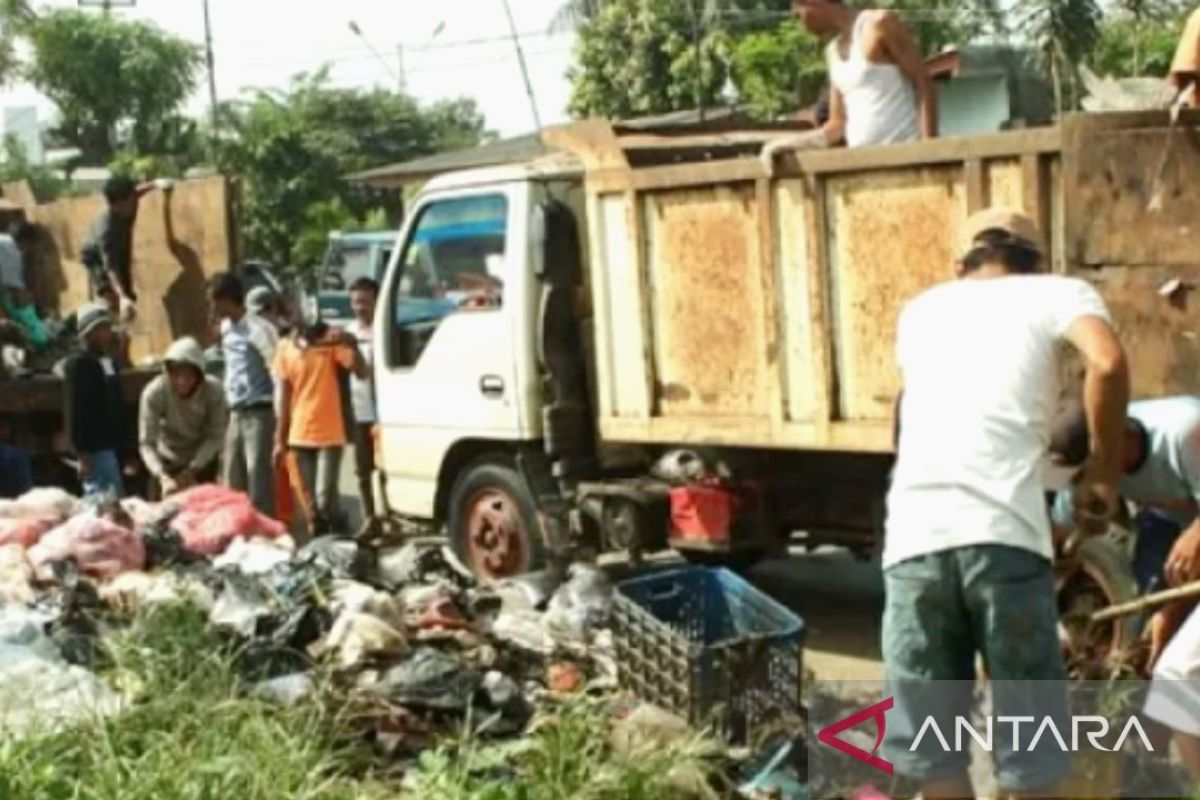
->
<box><xmin>0</xmin><ymin>606</ymin><xmax>710</xmax><ymax>800</ymax></box>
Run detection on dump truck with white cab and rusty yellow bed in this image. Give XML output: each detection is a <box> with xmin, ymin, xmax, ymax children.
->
<box><xmin>374</xmin><ymin>112</ymin><xmax>1200</xmax><ymax>578</ymax></box>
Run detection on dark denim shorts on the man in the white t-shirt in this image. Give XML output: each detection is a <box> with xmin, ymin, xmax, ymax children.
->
<box><xmin>883</xmin><ymin>545</ymin><xmax>1070</xmax><ymax>790</ymax></box>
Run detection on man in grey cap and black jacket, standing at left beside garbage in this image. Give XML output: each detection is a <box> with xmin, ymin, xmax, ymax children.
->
<box><xmin>64</xmin><ymin>303</ymin><xmax>125</xmax><ymax>497</ymax></box>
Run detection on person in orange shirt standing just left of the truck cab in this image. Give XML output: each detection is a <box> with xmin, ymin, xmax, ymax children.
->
<box><xmin>275</xmin><ymin>321</ymin><xmax>367</xmax><ymax>536</ymax></box>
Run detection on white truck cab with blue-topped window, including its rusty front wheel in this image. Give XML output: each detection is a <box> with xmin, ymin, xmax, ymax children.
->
<box><xmin>374</xmin><ymin>160</ymin><xmax>583</xmax><ymax>577</ymax></box>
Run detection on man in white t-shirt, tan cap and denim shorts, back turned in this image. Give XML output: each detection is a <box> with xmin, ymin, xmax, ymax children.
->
<box><xmin>883</xmin><ymin>209</ymin><xmax>1129</xmax><ymax>798</ymax></box>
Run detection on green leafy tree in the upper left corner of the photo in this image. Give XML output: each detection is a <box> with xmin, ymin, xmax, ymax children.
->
<box><xmin>17</xmin><ymin>10</ymin><xmax>203</xmax><ymax>163</ymax></box>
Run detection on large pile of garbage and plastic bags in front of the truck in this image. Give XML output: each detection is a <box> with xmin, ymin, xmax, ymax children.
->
<box><xmin>0</xmin><ymin>486</ymin><xmax>617</xmax><ymax>758</ymax></box>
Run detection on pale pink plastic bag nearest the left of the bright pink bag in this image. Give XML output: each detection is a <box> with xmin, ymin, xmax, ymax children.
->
<box><xmin>29</xmin><ymin>513</ymin><xmax>146</xmax><ymax>578</ymax></box>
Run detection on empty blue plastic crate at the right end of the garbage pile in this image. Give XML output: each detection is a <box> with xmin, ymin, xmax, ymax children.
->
<box><xmin>613</xmin><ymin>567</ymin><xmax>804</xmax><ymax>744</ymax></box>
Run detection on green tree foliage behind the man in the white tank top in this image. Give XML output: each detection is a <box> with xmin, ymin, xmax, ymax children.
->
<box><xmin>556</xmin><ymin>0</ymin><xmax>1002</xmax><ymax>118</ymax></box>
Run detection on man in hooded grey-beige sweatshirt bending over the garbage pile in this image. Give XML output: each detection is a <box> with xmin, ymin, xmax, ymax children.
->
<box><xmin>138</xmin><ymin>337</ymin><xmax>229</xmax><ymax>497</ymax></box>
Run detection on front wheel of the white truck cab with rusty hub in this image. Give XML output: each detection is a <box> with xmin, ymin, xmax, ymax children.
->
<box><xmin>446</xmin><ymin>457</ymin><xmax>546</xmax><ymax>581</ymax></box>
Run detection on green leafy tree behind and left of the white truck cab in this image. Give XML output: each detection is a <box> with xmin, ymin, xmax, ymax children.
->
<box><xmin>216</xmin><ymin>71</ymin><xmax>485</xmax><ymax>269</ymax></box>
